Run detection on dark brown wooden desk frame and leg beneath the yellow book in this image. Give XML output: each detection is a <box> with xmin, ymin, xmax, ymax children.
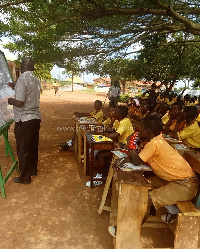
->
<box><xmin>84</xmin><ymin>132</ymin><xmax>114</xmax><ymax>188</ymax></box>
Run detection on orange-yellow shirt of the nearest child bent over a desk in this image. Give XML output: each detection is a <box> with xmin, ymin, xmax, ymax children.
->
<box><xmin>139</xmin><ymin>135</ymin><xmax>195</xmax><ymax>181</ymax></box>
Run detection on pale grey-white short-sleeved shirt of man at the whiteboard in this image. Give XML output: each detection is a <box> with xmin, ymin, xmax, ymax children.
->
<box><xmin>13</xmin><ymin>71</ymin><xmax>41</xmax><ymax>122</ymax></box>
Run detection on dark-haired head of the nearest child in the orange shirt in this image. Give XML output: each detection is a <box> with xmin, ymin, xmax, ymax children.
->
<box><xmin>139</xmin><ymin>115</ymin><xmax>163</xmax><ymax>141</ymax></box>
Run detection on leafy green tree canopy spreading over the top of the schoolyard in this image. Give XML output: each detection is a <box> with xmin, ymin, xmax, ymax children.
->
<box><xmin>0</xmin><ymin>0</ymin><xmax>200</xmax><ymax>85</ymax></box>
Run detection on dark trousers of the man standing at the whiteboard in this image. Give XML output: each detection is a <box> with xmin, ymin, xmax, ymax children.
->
<box><xmin>14</xmin><ymin>119</ymin><xmax>41</xmax><ymax>181</ymax></box>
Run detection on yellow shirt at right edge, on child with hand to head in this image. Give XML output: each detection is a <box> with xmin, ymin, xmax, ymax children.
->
<box><xmin>178</xmin><ymin>122</ymin><xmax>200</xmax><ymax>148</ymax></box>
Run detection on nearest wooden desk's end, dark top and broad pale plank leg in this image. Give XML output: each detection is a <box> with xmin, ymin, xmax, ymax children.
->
<box><xmin>110</xmin><ymin>171</ymin><xmax>150</xmax><ymax>249</ymax></box>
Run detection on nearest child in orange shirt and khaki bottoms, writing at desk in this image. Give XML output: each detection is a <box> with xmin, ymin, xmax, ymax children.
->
<box><xmin>109</xmin><ymin>116</ymin><xmax>198</xmax><ymax>235</ymax></box>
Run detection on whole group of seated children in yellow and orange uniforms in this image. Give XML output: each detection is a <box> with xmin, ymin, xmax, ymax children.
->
<box><xmin>63</xmin><ymin>94</ymin><xmax>200</xmax><ymax>237</ymax></box>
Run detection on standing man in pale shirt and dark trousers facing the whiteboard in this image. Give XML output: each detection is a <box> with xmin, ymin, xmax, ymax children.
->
<box><xmin>8</xmin><ymin>57</ymin><xmax>41</xmax><ymax>184</ymax></box>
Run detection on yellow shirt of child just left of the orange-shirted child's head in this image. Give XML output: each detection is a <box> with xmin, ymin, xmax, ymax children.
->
<box><xmin>113</xmin><ymin>118</ymin><xmax>134</xmax><ymax>144</ymax></box>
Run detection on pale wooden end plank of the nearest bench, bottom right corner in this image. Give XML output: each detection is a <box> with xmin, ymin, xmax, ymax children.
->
<box><xmin>174</xmin><ymin>213</ymin><xmax>200</xmax><ymax>249</ymax></box>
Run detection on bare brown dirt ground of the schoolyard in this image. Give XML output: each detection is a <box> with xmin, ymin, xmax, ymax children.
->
<box><xmin>0</xmin><ymin>90</ymin><xmax>173</xmax><ymax>249</ymax></box>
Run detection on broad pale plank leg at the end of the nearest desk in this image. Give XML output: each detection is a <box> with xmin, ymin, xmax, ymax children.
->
<box><xmin>116</xmin><ymin>183</ymin><xmax>148</xmax><ymax>249</ymax></box>
